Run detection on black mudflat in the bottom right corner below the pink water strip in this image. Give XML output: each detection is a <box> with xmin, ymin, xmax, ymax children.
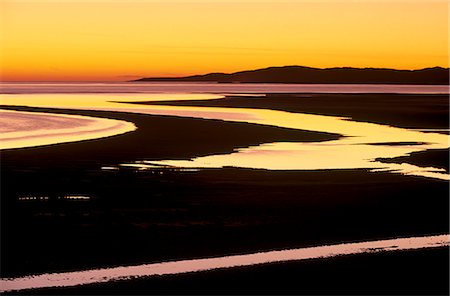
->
<box><xmin>17</xmin><ymin>248</ymin><xmax>449</xmax><ymax>295</ymax></box>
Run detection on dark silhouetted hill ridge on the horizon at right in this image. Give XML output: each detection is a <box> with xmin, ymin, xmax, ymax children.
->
<box><xmin>133</xmin><ymin>66</ymin><xmax>449</xmax><ymax>84</ymax></box>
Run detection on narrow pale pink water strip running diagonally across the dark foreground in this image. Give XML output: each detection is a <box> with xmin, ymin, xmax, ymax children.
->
<box><xmin>0</xmin><ymin>234</ymin><xmax>450</xmax><ymax>292</ymax></box>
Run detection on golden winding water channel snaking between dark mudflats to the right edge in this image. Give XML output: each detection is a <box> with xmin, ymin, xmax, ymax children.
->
<box><xmin>0</xmin><ymin>94</ymin><xmax>450</xmax><ymax>180</ymax></box>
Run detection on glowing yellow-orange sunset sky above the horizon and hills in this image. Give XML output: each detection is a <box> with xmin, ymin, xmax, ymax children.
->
<box><xmin>0</xmin><ymin>0</ymin><xmax>449</xmax><ymax>81</ymax></box>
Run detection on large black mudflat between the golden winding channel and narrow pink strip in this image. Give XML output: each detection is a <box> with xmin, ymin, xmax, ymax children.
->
<box><xmin>1</xmin><ymin>100</ymin><xmax>449</xmax><ymax>294</ymax></box>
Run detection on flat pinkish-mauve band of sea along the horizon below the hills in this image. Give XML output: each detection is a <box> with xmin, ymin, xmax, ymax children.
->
<box><xmin>0</xmin><ymin>82</ymin><xmax>449</xmax><ymax>94</ymax></box>
